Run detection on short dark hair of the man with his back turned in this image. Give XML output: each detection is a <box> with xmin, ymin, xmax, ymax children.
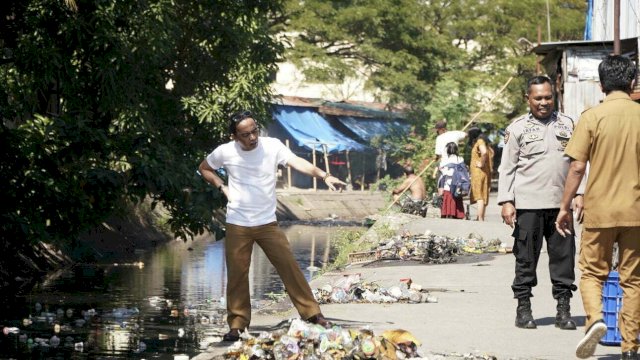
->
<box><xmin>598</xmin><ymin>55</ymin><xmax>637</xmax><ymax>94</ymax></box>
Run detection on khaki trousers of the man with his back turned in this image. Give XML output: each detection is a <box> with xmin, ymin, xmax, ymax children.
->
<box><xmin>578</xmin><ymin>227</ymin><xmax>640</xmax><ymax>352</ymax></box>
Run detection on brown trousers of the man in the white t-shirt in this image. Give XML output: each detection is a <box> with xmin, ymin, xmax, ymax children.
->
<box><xmin>224</xmin><ymin>222</ymin><xmax>320</xmax><ymax>329</ymax></box>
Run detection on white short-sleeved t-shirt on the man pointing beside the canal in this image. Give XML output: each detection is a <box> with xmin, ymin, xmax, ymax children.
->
<box><xmin>207</xmin><ymin>137</ymin><xmax>295</xmax><ymax>226</ymax></box>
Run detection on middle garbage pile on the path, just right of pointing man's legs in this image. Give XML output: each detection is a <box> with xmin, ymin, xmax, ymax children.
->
<box><xmin>313</xmin><ymin>274</ymin><xmax>438</xmax><ymax>304</ymax></box>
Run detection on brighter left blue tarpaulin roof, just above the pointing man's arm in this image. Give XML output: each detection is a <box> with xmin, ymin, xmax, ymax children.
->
<box><xmin>273</xmin><ymin>105</ymin><xmax>367</xmax><ymax>153</ymax></box>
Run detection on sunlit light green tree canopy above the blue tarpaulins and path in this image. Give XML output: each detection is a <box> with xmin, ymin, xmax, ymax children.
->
<box><xmin>278</xmin><ymin>0</ymin><xmax>586</xmax><ymax>168</ymax></box>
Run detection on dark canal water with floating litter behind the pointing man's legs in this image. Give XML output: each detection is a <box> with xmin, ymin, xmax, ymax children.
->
<box><xmin>0</xmin><ymin>224</ymin><xmax>360</xmax><ymax>359</ymax></box>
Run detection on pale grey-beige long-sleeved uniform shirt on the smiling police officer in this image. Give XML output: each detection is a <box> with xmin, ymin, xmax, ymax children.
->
<box><xmin>498</xmin><ymin>112</ymin><xmax>574</xmax><ymax>209</ymax></box>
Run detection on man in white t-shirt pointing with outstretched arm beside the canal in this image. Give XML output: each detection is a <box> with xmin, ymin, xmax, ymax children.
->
<box><xmin>199</xmin><ymin>111</ymin><xmax>346</xmax><ymax>341</ymax></box>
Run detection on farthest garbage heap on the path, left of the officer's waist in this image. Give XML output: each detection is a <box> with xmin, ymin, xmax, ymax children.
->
<box><xmin>362</xmin><ymin>231</ymin><xmax>504</xmax><ymax>264</ymax></box>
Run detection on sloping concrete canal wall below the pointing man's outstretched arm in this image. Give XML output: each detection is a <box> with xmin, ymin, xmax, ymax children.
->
<box><xmin>276</xmin><ymin>189</ymin><xmax>390</xmax><ymax>221</ymax></box>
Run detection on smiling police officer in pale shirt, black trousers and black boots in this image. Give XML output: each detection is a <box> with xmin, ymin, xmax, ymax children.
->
<box><xmin>498</xmin><ymin>76</ymin><xmax>577</xmax><ymax>330</ymax></box>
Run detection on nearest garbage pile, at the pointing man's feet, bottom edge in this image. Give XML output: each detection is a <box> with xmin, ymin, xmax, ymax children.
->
<box><xmin>225</xmin><ymin>319</ymin><xmax>420</xmax><ymax>360</ymax></box>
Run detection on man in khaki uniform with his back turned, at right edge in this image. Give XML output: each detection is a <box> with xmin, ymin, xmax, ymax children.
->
<box><xmin>556</xmin><ymin>55</ymin><xmax>640</xmax><ymax>359</ymax></box>
